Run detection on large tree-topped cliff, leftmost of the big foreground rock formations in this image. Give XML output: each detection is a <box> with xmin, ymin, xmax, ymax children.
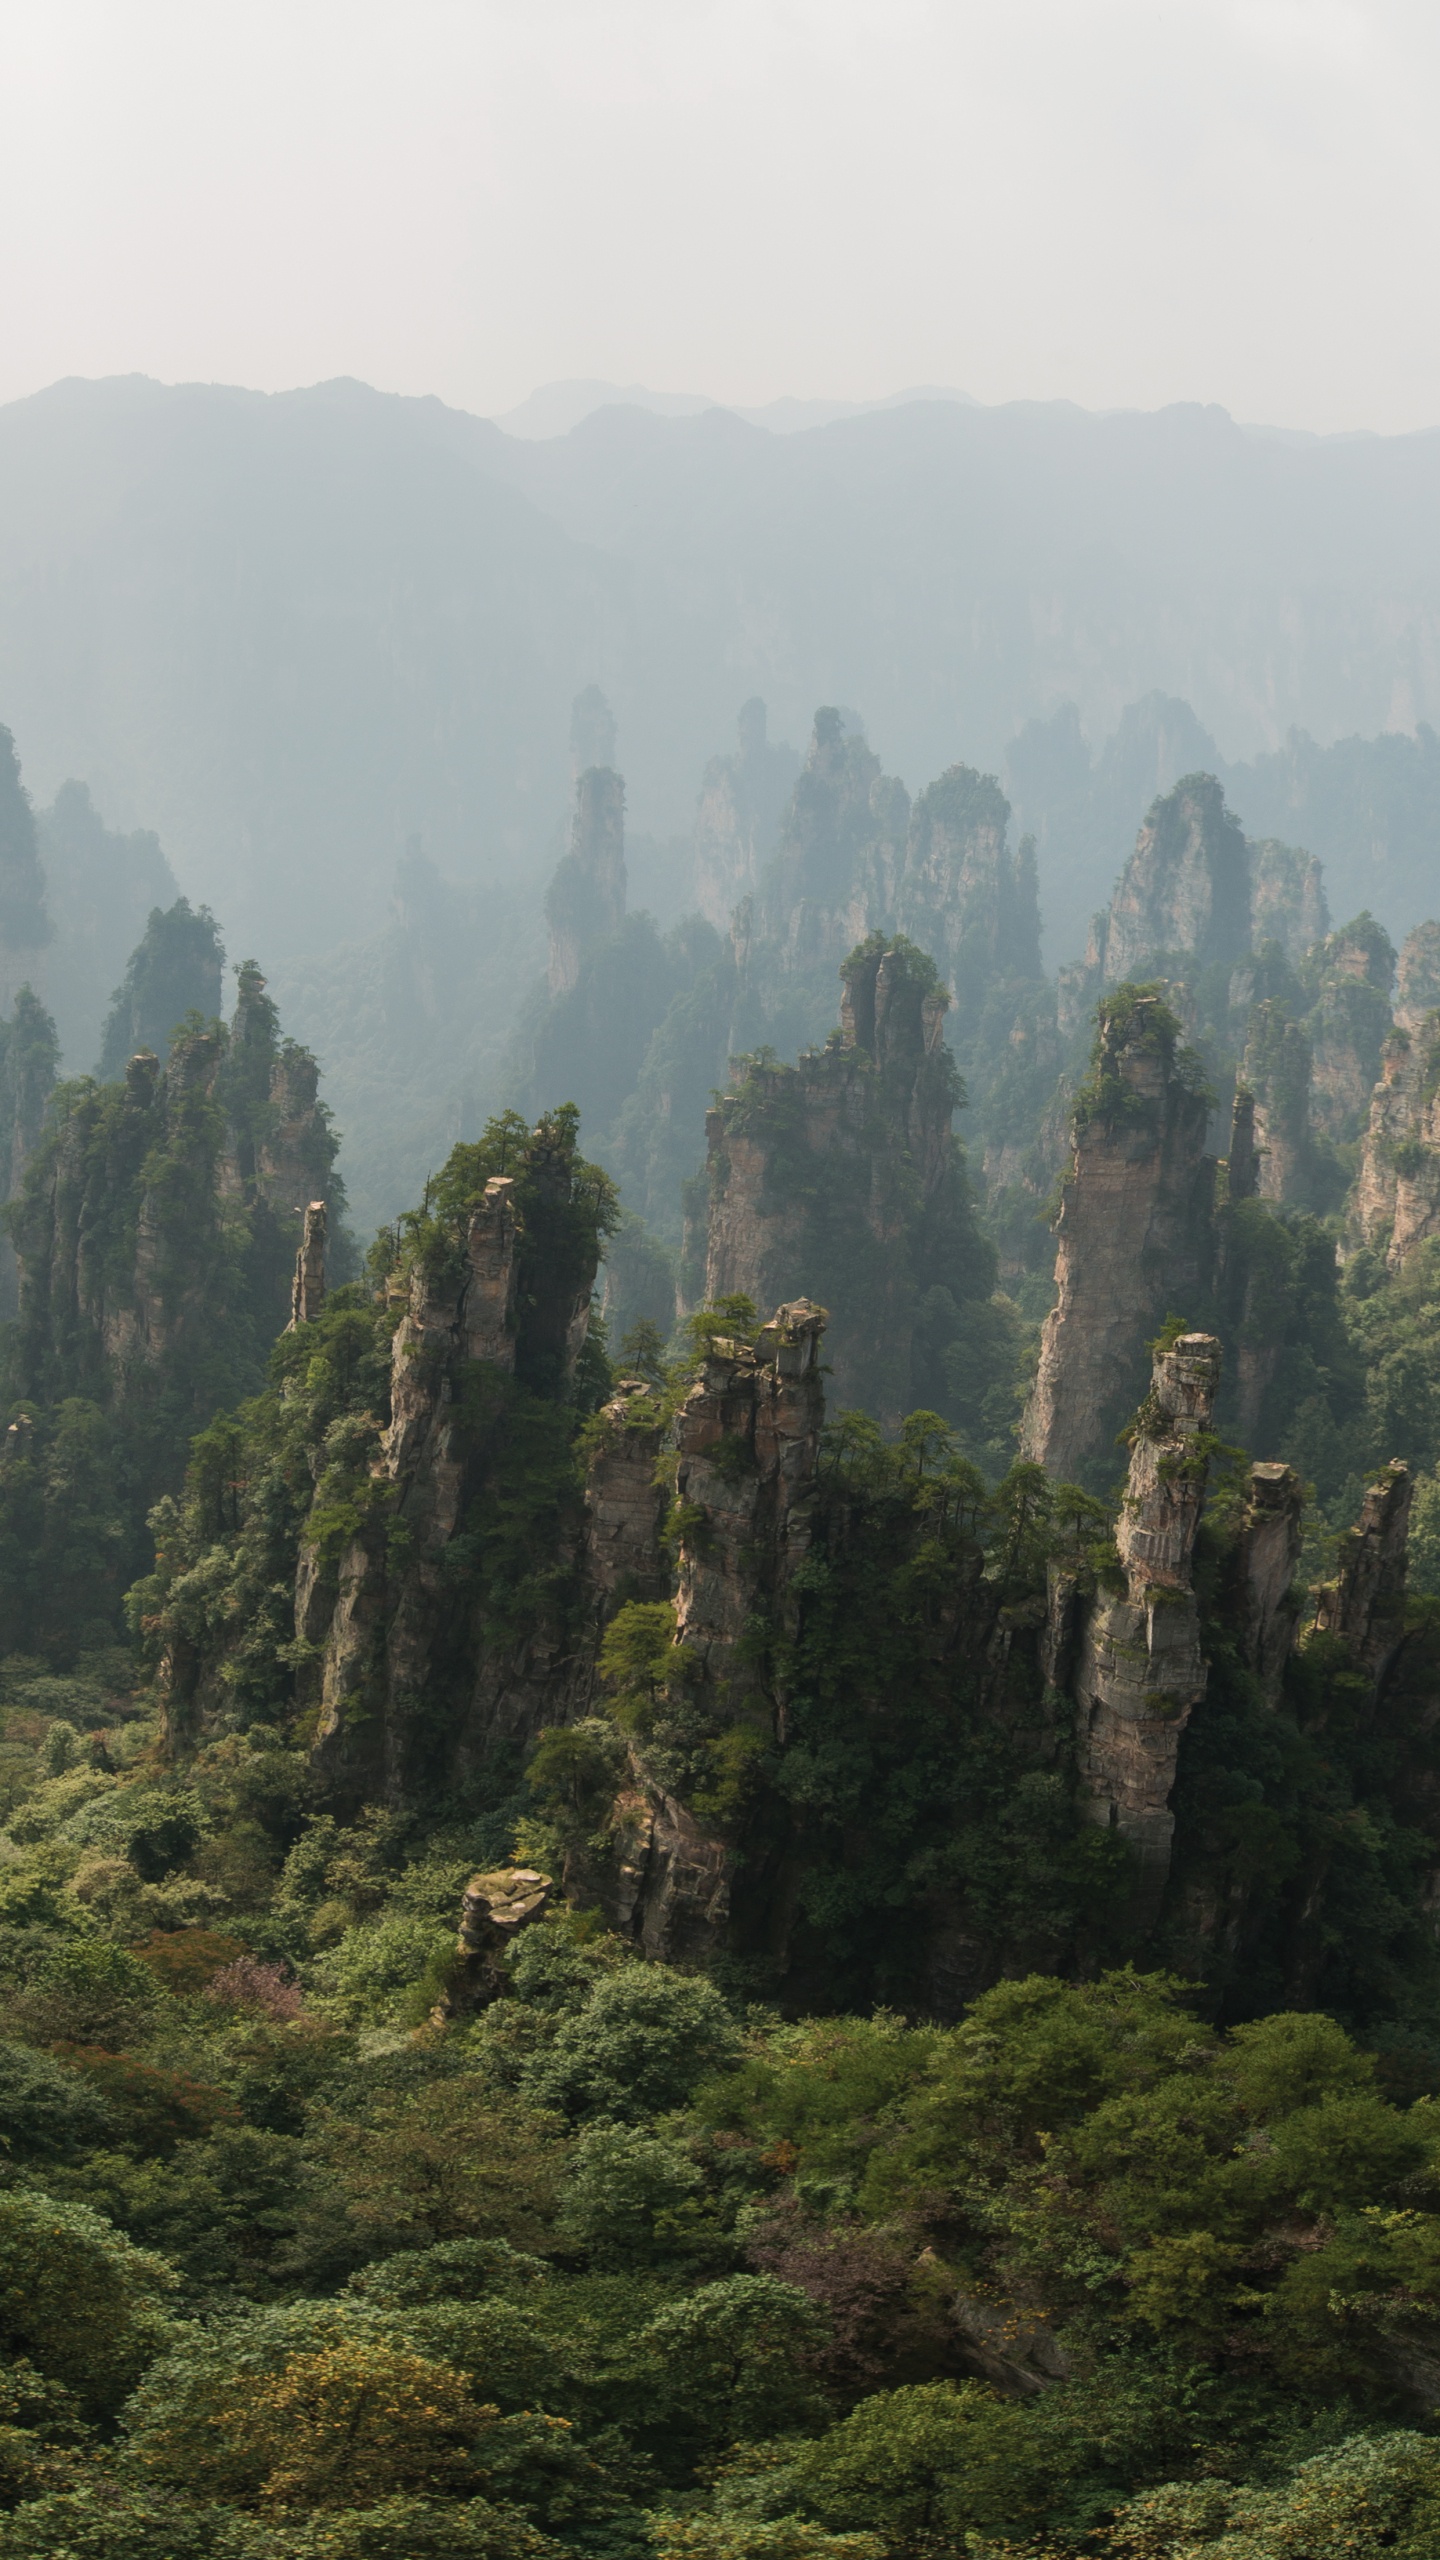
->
<box><xmin>295</xmin><ymin>1116</ymin><xmax>604</xmax><ymax>1802</ymax></box>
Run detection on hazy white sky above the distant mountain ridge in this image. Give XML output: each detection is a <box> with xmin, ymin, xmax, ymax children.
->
<box><xmin>0</xmin><ymin>0</ymin><xmax>1440</xmax><ymax>428</ymax></box>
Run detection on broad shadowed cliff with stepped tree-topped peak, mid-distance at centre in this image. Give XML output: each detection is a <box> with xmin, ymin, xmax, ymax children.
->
<box><xmin>705</xmin><ymin>937</ymin><xmax>963</xmax><ymax>1421</ymax></box>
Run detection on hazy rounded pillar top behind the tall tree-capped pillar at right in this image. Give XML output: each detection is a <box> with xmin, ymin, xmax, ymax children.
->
<box><xmin>1094</xmin><ymin>773</ymin><xmax>1250</xmax><ymax>986</ymax></box>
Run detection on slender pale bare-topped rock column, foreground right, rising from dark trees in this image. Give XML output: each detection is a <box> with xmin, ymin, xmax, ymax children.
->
<box><xmin>1076</xmin><ymin>1334</ymin><xmax>1220</xmax><ymax>1917</ymax></box>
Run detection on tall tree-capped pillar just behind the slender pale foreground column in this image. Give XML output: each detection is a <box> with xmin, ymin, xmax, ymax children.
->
<box><xmin>1022</xmin><ymin>993</ymin><xmax>1215</xmax><ymax>1480</ymax></box>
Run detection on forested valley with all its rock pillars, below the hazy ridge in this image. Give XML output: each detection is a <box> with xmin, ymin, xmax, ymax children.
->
<box><xmin>11</xmin><ymin>624</ymin><xmax>1440</xmax><ymax>2560</ymax></box>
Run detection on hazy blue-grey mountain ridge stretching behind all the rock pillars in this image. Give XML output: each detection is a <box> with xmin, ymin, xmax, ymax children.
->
<box><xmin>0</xmin><ymin>376</ymin><xmax>1440</xmax><ymax>977</ymax></box>
